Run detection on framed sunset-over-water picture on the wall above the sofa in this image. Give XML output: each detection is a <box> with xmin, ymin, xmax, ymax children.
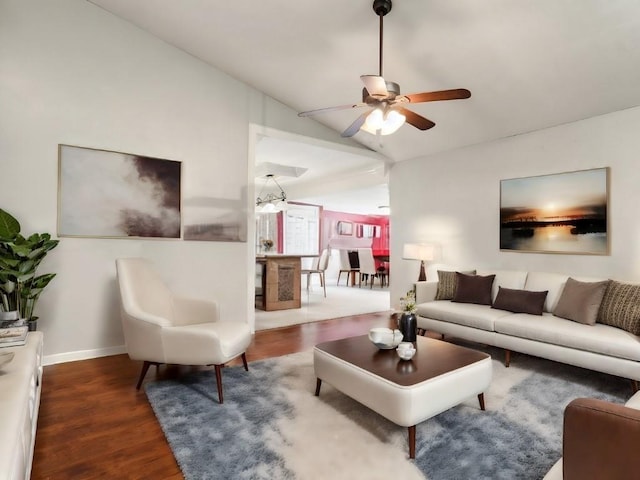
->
<box><xmin>500</xmin><ymin>168</ymin><xmax>609</xmax><ymax>255</ymax></box>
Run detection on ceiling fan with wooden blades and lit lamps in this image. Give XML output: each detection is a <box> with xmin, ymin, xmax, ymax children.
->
<box><xmin>298</xmin><ymin>0</ymin><xmax>471</xmax><ymax>137</ymax></box>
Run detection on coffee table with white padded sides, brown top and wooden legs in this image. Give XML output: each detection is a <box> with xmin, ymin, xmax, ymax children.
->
<box><xmin>313</xmin><ymin>335</ymin><xmax>492</xmax><ymax>458</ymax></box>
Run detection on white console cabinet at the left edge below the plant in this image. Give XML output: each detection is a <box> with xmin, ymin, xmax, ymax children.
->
<box><xmin>0</xmin><ymin>332</ymin><xmax>42</xmax><ymax>480</ymax></box>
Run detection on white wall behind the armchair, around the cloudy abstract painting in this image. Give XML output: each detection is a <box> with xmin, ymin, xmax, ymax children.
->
<box><xmin>0</xmin><ymin>0</ymin><xmax>360</xmax><ymax>362</ymax></box>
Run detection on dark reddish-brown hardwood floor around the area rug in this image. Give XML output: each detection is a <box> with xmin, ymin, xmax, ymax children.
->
<box><xmin>31</xmin><ymin>313</ymin><xmax>394</xmax><ymax>480</ymax></box>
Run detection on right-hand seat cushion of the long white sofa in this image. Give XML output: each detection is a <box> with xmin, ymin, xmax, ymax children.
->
<box><xmin>494</xmin><ymin>313</ymin><xmax>640</xmax><ymax>361</ymax></box>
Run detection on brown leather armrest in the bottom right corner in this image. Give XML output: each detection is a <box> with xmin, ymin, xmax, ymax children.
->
<box><xmin>562</xmin><ymin>398</ymin><xmax>640</xmax><ymax>480</ymax></box>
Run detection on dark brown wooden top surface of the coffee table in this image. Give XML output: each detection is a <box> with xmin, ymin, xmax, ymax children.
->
<box><xmin>316</xmin><ymin>335</ymin><xmax>490</xmax><ymax>387</ymax></box>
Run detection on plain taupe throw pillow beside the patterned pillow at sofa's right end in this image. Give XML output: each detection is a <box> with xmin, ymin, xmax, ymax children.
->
<box><xmin>553</xmin><ymin>278</ymin><xmax>609</xmax><ymax>325</ymax></box>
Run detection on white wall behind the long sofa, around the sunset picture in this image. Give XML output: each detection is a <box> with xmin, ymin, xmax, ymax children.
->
<box><xmin>389</xmin><ymin>108</ymin><xmax>640</xmax><ymax>305</ymax></box>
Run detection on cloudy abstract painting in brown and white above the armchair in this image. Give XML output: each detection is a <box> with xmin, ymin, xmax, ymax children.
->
<box><xmin>58</xmin><ymin>144</ymin><xmax>182</xmax><ymax>239</ymax></box>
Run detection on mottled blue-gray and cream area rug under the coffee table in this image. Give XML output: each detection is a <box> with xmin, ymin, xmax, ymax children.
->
<box><xmin>146</xmin><ymin>346</ymin><xmax>631</xmax><ymax>480</ymax></box>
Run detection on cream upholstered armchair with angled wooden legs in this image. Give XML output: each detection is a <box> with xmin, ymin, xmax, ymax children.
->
<box><xmin>116</xmin><ymin>258</ymin><xmax>251</xmax><ymax>403</ymax></box>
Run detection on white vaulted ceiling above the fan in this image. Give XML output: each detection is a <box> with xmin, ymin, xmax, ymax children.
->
<box><xmin>89</xmin><ymin>0</ymin><xmax>640</xmax><ymax>212</ymax></box>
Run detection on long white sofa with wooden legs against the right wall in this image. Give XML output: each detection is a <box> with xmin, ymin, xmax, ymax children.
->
<box><xmin>415</xmin><ymin>270</ymin><xmax>640</xmax><ymax>381</ymax></box>
